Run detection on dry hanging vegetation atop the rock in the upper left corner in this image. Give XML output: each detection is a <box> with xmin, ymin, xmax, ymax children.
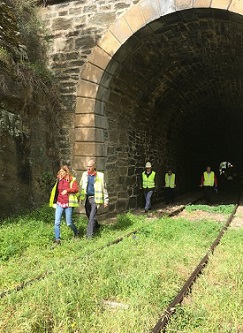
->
<box><xmin>0</xmin><ymin>0</ymin><xmax>56</xmax><ymax>94</ymax></box>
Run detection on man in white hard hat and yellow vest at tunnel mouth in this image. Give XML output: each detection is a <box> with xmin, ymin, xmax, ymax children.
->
<box><xmin>140</xmin><ymin>162</ymin><xmax>156</xmax><ymax>213</ymax></box>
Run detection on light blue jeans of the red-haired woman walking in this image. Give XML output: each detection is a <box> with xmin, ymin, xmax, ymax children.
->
<box><xmin>54</xmin><ymin>205</ymin><xmax>78</xmax><ymax>239</ymax></box>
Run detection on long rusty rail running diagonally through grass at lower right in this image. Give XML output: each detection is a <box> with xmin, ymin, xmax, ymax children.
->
<box><xmin>151</xmin><ymin>203</ymin><xmax>239</xmax><ymax>333</ymax></box>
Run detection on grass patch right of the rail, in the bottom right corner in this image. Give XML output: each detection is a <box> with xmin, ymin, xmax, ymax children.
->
<box><xmin>167</xmin><ymin>229</ymin><xmax>243</xmax><ymax>333</ymax></box>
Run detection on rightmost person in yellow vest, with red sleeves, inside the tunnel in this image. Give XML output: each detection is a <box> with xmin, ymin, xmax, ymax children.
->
<box><xmin>200</xmin><ymin>166</ymin><xmax>218</xmax><ymax>204</ymax></box>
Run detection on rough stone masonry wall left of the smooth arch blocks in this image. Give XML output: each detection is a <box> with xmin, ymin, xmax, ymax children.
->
<box><xmin>40</xmin><ymin>0</ymin><xmax>139</xmax><ymax>163</ymax></box>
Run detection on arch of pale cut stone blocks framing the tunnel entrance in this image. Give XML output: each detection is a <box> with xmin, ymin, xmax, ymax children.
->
<box><xmin>73</xmin><ymin>0</ymin><xmax>243</xmax><ymax>213</ymax></box>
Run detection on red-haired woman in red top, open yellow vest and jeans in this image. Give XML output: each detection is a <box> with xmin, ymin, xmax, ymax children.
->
<box><xmin>49</xmin><ymin>165</ymin><xmax>79</xmax><ymax>244</ymax></box>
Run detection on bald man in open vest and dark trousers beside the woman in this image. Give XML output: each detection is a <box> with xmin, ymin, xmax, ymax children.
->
<box><xmin>80</xmin><ymin>160</ymin><xmax>109</xmax><ymax>238</ymax></box>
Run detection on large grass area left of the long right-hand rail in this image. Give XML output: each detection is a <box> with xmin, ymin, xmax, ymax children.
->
<box><xmin>0</xmin><ymin>204</ymin><xmax>235</xmax><ymax>333</ymax></box>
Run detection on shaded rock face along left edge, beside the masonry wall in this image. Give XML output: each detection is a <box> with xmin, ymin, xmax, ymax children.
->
<box><xmin>0</xmin><ymin>3</ymin><xmax>59</xmax><ymax>217</ymax></box>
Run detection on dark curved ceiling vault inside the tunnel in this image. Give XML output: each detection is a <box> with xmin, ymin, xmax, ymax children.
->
<box><xmin>102</xmin><ymin>9</ymin><xmax>243</xmax><ymax>171</ymax></box>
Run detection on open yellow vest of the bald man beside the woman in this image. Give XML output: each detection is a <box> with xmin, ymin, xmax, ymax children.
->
<box><xmin>80</xmin><ymin>171</ymin><xmax>108</xmax><ymax>204</ymax></box>
